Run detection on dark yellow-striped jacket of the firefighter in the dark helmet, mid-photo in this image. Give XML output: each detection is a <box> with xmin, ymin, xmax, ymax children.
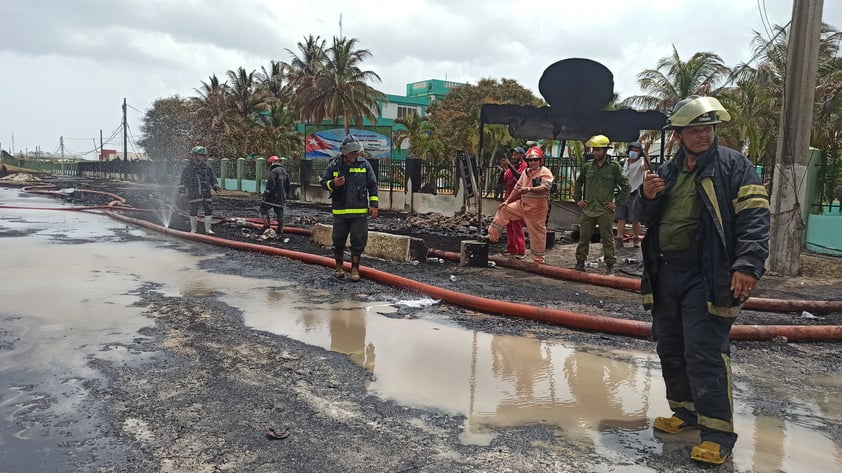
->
<box><xmin>321</xmin><ymin>156</ymin><xmax>378</xmax><ymax>217</ymax></box>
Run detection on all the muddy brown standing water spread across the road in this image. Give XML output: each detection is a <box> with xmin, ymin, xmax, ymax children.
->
<box><xmin>0</xmin><ymin>186</ymin><xmax>842</xmax><ymax>472</ymax></box>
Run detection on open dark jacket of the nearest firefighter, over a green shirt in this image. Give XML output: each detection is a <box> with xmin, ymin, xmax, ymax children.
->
<box><xmin>634</xmin><ymin>140</ymin><xmax>770</xmax><ymax>317</ymax></box>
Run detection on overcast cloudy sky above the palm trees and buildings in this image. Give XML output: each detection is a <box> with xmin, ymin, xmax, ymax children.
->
<box><xmin>0</xmin><ymin>0</ymin><xmax>842</xmax><ymax>159</ymax></box>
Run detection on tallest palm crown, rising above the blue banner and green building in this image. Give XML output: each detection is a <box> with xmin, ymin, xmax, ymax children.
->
<box><xmin>292</xmin><ymin>37</ymin><xmax>386</xmax><ymax>133</ymax></box>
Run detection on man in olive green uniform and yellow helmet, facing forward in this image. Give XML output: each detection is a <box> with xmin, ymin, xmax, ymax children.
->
<box><xmin>573</xmin><ymin>135</ymin><xmax>629</xmax><ymax>274</ymax></box>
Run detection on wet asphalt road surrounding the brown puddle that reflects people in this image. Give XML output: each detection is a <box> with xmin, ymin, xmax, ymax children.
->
<box><xmin>0</xmin><ymin>182</ymin><xmax>842</xmax><ymax>472</ymax></box>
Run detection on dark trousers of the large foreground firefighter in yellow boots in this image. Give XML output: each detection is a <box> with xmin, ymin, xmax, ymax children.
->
<box><xmin>652</xmin><ymin>251</ymin><xmax>737</xmax><ymax>448</ymax></box>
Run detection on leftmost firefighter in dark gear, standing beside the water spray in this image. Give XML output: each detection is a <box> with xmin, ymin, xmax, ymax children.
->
<box><xmin>178</xmin><ymin>146</ymin><xmax>219</xmax><ymax>235</ymax></box>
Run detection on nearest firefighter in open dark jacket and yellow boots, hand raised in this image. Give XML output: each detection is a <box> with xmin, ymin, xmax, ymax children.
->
<box><xmin>634</xmin><ymin>95</ymin><xmax>770</xmax><ymax>464</ymax></box>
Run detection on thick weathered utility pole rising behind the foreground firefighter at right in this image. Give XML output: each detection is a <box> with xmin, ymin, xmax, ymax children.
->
<box><xmin>768</xmin><ymin>0</ymin><xmax>823</xmax><ymax>276</ymax></box>
